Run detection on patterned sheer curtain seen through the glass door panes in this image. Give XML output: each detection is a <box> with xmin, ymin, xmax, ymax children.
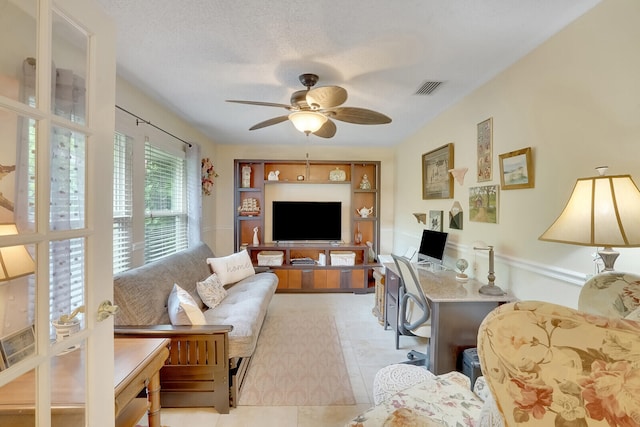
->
<box><xmin>16</xmin><ymin>58</ymin><xmax>87</xmax><ymax>334</ymax></box>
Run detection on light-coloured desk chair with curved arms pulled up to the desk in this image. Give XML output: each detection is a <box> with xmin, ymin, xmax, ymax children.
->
<box><xmin>391</xmin><ymin>254</ymin><xmax>431</xmax><ymax>365</ymax></box>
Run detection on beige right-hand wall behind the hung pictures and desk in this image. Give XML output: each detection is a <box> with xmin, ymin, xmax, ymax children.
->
<box><xmin>393</xmin><ymin>0</ymin><xmax>640</xmax><ymax>306</ymax></box>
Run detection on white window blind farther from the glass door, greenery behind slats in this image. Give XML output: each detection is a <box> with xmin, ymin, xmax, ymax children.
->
<box><xmin>144</xmin><ymin>142</ymin><xmax>188</xmax><ymax>263</ymax></box>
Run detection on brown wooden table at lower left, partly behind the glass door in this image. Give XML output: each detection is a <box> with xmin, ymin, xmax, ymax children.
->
<box><xmin>0</xmin><ymin>338</ymin><xmax>170</xmax><ymax>427</ymax></box>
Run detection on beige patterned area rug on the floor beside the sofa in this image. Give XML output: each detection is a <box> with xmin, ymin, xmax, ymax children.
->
<box><xmin>238</xmin><ymin>313</ymin><xmax>355</xmax><ymax>406</ymax></box>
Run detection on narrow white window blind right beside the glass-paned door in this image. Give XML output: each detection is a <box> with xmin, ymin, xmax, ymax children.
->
<box><xmin>113</xmin><ymin>132</ymin><xmax>133</xmax><ymax>274</ymax></box>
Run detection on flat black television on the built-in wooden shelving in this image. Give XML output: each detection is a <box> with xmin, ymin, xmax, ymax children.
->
<box><xmin>271</xmin><ymin>200</ymin><xmax>342</xmax><ymax>242</ymax></box>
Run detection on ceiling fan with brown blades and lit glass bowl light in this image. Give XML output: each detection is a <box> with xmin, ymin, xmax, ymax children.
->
<box><xmin>227</xmin><ymin>73</ymin><xmax>391</xmax><ymax>138</ymax></box>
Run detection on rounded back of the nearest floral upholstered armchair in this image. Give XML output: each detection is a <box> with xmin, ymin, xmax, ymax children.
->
<box><xmin>478</xmin><ymin>301</ymin><xmax>640</xmax><ymax>427</ymax></box>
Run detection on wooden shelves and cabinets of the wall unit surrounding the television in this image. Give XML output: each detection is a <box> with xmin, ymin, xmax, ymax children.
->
<box><xmin>234</xmin><ymin>159</ymin><xmax>380</xmax><ymax>292</ymax></box>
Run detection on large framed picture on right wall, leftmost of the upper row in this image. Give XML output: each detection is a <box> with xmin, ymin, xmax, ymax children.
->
<box><xmin>422</xmin><ymin>143</ymin><xmax>453</xmax><ymax>200</ymax></box>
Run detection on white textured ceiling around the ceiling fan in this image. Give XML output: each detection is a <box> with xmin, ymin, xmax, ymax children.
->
<box><xmin>98</xmin><ymin>0</ymin><xmax>599</xmax><ymax>146</ymax></box>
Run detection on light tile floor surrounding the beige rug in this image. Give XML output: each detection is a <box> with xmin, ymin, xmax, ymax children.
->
<box><xmin>140</xmin><ymin>293</ymin><xmax>427</xmax><ymax>427</ymax></box>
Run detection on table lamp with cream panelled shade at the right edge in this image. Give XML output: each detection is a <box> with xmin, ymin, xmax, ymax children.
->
<box><xmin>539</xmin><ymin>166</ymin><xmax>640</xmax><ymax>272</ymax></box>
